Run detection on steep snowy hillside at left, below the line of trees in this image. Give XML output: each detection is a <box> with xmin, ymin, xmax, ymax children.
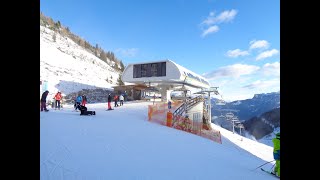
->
<box><xmin>40</xmin><ymin>26</ymin><xmax>120</xmax><ymax>97</ymax></box>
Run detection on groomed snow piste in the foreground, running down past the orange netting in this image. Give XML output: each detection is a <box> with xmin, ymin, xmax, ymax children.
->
<box><xmin>40</xmin><ymin>102</ymin><xmax>277</xmax><ymax>180</ymax></box>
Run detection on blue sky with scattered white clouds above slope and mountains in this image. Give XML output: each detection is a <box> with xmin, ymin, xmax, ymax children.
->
<box><xmin>40</xmin><ymin>0</ymin><xmax>280</xmax><ymax>101</ymax></box>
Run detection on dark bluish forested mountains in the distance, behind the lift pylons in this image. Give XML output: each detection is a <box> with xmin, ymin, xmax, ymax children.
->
<box><xmin>211</xmin><ymin>92</ymin><xmax>280</xmax><ymax>146</ymax></box>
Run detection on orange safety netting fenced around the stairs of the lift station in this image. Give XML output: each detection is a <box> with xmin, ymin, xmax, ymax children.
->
<box><xmin>148</xmin><ymin>101</ymin><xmax>222</xmax><ymax>144</ymax></box>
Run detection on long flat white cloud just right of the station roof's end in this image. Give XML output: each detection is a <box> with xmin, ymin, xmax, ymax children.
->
<box><xmin>204</xmin><ymin>64</ymin><xmax>260</xmax><ymax>79</ymax></box>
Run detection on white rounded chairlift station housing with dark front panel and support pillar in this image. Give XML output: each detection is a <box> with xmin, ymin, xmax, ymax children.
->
<box><xmin>121</xmin><ymin>60</ymin><xmax>210</xmax><ymax>102</ymax></box>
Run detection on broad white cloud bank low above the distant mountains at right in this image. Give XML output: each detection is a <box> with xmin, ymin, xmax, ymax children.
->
<box><xmin>203</xmin><ymin>62</ymin><xmax>280</xmax><ymax>101</ymax></box>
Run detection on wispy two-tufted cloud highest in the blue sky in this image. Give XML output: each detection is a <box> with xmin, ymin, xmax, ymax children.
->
<box><xmin>201</xmin><ymin>9</ymin><xmax>238</xmax><ymax>37</ymax></box>
